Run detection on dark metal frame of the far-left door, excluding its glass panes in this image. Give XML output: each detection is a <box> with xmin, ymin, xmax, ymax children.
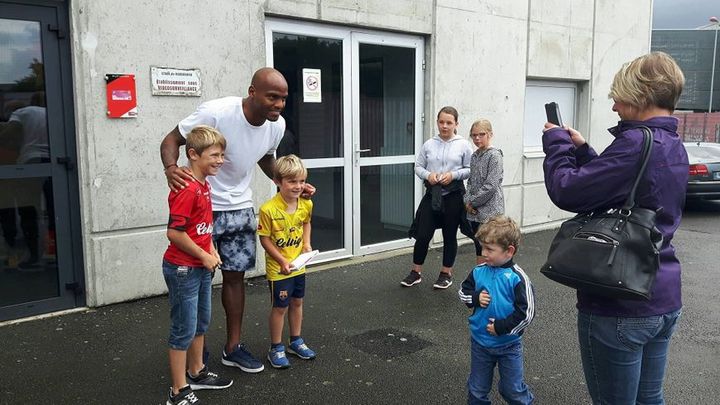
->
<box><xmin>0</xmin><ymin>0</ymin><xmax>85</xmax><ymax>320</ymax></box>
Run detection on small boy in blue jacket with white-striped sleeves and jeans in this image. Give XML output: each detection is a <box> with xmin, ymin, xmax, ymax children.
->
<box><xmin>458</xmin><ymin>215</ymin><xmax>535</xmax><ymax>405</ymax></box>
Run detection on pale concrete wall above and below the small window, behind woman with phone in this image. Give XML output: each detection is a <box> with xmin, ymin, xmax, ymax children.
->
<box><xmin>522</xmin><ymin>0</ymin><xmax>652</xmax><ymax>230</ymax></box>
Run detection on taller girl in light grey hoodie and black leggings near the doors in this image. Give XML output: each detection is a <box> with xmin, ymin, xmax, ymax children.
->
<box><xmin>400</xmin><ymin>107</ymin><xmax>472</xmax><ymax>289</ymax></box>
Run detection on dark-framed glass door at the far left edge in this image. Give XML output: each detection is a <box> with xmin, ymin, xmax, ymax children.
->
<box><xmin>0</xmin><ymin>3</ymin><xmax>82</xmax><ymax>320</ymax></box>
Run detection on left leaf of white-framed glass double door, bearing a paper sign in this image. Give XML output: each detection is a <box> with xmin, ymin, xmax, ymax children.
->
<box><xmin>266</xmin><ymin>19</ymin><xmax>352</xmax><ymax>260</ymax></box>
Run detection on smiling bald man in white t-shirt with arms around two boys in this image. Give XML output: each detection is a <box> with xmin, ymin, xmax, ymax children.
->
<box><xmin>160</xmin><ymin>67</ymin><xmax>315</xmax><ymax>373</ymax></box>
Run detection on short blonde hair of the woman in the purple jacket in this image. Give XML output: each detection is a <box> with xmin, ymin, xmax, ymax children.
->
<box><xmin>608</xmin><ymin>52</ymin><xmax>685</xmax><ymax>111</ymax></box>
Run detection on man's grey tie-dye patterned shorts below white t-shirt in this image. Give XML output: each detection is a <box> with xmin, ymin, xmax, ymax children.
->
<box><xmin>213</xmin><ymin>208</ymin><xmax>257</xmax><ymax>271</ymax></box>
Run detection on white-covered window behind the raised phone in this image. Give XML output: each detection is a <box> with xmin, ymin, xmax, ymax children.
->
<box><xmin>523</xmin><ymin>81</ymin><xmax>578</xmax><ymax>152</ymax></box>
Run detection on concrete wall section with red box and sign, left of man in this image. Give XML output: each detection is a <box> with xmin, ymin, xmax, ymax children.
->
<box><xmin>71</xmin><ymin>0</ymin><xmax>265</xmax><ymax>306</ymax></box>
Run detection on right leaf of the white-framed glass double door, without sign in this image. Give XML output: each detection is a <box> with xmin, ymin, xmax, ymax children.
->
<box><xmin>352</xmin><ymin>33</ymin><xmax>423</xmax><ymax>254</ymax></box>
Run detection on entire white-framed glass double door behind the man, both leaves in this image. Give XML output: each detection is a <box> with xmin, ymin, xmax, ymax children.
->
<box><xmin>266</xmin><ymin>19</ymin><xmax>423</xmax><ymax>260</ymax></box>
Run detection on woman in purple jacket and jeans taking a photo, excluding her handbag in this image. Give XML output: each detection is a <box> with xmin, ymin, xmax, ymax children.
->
<box><xmin>543</xmin><ymin>52</ymin><xmax>688</xmax><ymax>405</ymax></box>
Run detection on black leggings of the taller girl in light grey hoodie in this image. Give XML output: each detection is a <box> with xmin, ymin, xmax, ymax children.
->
<box><xmin>413</xmin><ymin>190</ymin><xmax>465</xmax><ymax>267</ymax></box>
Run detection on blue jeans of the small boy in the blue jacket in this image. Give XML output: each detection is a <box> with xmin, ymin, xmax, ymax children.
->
<box><xmin>468</xmin><ymin>338</ymin><xmax>534</xmax><ymax>405</ymax></box>
